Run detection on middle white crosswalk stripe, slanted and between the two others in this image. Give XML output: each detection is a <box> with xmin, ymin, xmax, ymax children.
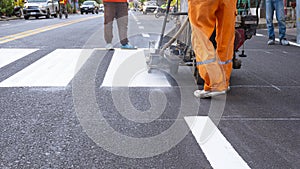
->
<box><xmin>0</xmin><ymin>49</ymin><xmax>93</xmax><ymax>87</ymax></box>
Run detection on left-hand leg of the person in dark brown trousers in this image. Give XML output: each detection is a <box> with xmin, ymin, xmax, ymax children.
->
<box><xmin>104</xmin><ymin>3</ymin><xmax>116</xmax><ymax>43</ymax></box>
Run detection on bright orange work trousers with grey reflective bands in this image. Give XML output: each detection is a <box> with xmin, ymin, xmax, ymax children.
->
<box><xmin>188</xmin><ymin>0</ymin><xmax>236</xmax><ymax>91</ymax></box>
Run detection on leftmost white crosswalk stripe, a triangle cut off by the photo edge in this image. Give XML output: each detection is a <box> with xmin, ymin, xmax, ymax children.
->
<box><xmin>0</xmin><ymin>48</ymin><xmax>38</xmax><ymax>68</ymax></box>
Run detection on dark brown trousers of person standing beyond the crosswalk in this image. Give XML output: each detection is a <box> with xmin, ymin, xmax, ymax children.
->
<box><xmin>104</xmin><ymin>2</ymin><xmax>128</xmax><ymax>45</ymax></box>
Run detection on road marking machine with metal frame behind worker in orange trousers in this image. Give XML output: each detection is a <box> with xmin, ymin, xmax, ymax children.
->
<box><xmin>145</xmin><ymin>0</ymin><xmax>260</xmax><ymax>84</ymax></box>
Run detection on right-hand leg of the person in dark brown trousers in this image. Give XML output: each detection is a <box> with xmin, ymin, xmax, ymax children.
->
<box><xmin>117</xmin><ymin>2</ymin><xmax>128</xmax><ymax>45</ymax></box>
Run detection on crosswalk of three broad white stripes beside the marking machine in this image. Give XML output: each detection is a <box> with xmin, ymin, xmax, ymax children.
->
<box><xmin>0</xmin><ymin>49</ymin><xmax>170</xmax><ymax>87</ymax></box>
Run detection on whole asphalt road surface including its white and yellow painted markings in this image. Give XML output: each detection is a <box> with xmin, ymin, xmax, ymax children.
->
<box><xmin>0</xmin><ymin>12</ymin><xmax>300</xmax><ymax>169</ymax></box>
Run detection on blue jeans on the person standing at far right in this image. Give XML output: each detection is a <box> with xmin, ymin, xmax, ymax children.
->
<box><xmin>266</xmin><ymin>0</ymin><xmax>286</xmax><ymax>39</ymax></box>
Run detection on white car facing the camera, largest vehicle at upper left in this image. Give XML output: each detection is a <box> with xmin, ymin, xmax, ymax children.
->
<box><xmin>23</xmin><ymin>0</ymin><xmax>59</xmax><ymax>20</ymax></box>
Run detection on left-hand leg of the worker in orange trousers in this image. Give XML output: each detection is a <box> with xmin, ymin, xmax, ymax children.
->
<box><xmin>188</xmin><ymin>0</ymin><xmax>224</xmax><ymax>91</ymax></box>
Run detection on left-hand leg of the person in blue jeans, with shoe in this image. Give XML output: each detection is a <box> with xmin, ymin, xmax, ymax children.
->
<box><xmin>266</xmin><ymin>0</ymin><xmax>275</xmax><ymax>45</ymax></box>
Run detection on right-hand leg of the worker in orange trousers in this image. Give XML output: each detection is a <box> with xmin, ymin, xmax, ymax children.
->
<box><xmin>216</xmin><ymin>0</ymin><xmax>236</xmax><ymax>90</ymax></box>
